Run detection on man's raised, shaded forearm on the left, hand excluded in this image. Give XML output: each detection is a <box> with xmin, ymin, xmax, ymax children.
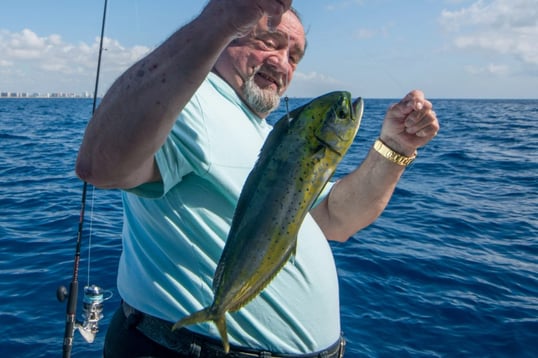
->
<box><xmin>77</xmin><ymin>5</ymin><xmax>234</xmax><ymax>188</ymax></box>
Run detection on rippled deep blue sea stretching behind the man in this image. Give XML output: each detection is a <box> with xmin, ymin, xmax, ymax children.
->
<box><xmin>0</xmin><ymin>99</ymin><xmax>538</xmax><ymax>357</ymax></box>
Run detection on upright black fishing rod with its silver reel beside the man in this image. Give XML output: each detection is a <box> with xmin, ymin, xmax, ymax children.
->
<box><xmin>56</xmin><ymin>0</ymin><xmax>110</xmax><ymax>358</ymax></box>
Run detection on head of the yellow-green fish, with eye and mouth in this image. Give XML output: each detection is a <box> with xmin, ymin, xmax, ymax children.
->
<box><xmin>310</xmin><ymin>91</ymin><xmax>364</xmax><ymax>156</ymax></box>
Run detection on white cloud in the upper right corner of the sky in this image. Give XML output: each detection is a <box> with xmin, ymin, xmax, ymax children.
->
<box><xmin>440</xmin><ymin>0</ymin><xmax>538</xmax><ymax>73</ymax></box>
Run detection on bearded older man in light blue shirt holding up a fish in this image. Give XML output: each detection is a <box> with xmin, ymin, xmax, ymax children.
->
<box><xmin>76</xmin><ymin>0</ymin><xmax>439</xmax><ymax>357</ymax></box>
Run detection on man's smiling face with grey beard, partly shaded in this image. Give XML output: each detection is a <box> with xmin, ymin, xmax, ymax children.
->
<box><xmin>215</xmin><ymin>11</ymin><xmax>306</xmax><ymax>117</ymax></box>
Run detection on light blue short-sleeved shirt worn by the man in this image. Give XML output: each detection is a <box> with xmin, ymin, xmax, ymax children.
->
<box><xmin>118</xmin><ymin>73</ymin><xmax>340</xmax><ymax>353</ymax></box>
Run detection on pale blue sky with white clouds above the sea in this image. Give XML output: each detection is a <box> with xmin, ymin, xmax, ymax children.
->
<box><xmin>0</xmin><ymin>0</ymin><xmax>538</xmax><ymax>99</ymax></box>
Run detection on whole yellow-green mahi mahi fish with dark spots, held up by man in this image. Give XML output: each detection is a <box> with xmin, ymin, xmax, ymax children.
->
<box><xmin>172</xmin><ymin>91</ymin><xmax>363</xmax><ymax>353</ymax></box>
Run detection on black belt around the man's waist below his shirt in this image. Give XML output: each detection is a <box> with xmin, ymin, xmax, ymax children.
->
<box><xmin>122</xmin><ymin>302</ymin><xmax>346</xmax><ymax>358</ymax></box>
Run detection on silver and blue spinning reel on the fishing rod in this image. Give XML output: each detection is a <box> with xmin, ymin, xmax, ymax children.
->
<box><xmin>56</xmin><ymin>285</ymin><xmax>112</xmax><ymax>343</ymax></box>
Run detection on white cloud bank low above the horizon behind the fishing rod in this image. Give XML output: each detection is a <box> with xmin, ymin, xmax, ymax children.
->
<box><xmin>0</xmin><ymin>29</ymin><xmax>150</xmax><ymax>92</ymax></box>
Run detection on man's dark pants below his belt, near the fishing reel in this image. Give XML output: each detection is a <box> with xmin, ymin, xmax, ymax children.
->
<box><xmin>103</xmin><ymin>308</ymin><xmax>183</xmax><ymax>358</ymax></box>
